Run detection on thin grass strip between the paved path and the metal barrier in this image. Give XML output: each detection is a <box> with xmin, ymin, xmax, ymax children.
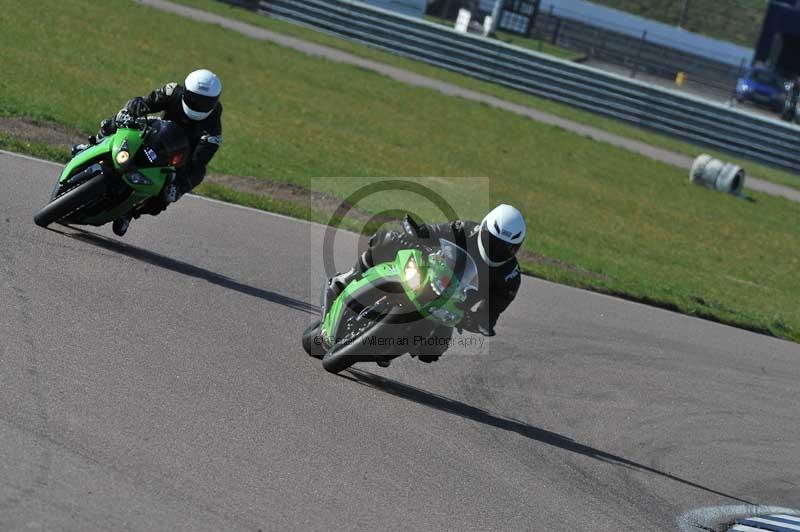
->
<box><xmin>169</xmin><ymin>0</ymin><xmax>800</xmax><ymax>190</ymax></box>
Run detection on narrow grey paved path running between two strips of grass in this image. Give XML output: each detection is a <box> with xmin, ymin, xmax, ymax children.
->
<box><xmin>136</xmin><ymin>0</ymin><xmax>800</xmax><ymax>201</ymax></box>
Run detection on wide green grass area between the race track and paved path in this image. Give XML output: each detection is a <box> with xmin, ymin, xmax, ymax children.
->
<box><xmin>0</xmin><ymin>0</ymin><xmax>800</xmax><ymax>341</ymax></box>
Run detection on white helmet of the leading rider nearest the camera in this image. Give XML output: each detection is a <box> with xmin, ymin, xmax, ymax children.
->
<box><xmin>478</xmin><ymin>204</ymin><xmax>525</xmax><ymax>266</ymax></box>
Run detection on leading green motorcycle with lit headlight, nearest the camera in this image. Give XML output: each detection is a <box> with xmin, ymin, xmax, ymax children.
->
<box><xmin>302</xmin><ymin>239</ymin><xmax>478</xmax><ymax>373</ymax></box>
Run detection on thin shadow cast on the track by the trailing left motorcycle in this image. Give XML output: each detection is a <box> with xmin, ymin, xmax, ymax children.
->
<box><xmin>49</xmin><ymin>225</ymin><xmax>319</xmax><ymax>315</ymax></box>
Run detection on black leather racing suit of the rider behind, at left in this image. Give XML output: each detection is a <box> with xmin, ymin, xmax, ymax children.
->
<box><xmin>98</xmin><ymin>83</ymin><xmax>222</xmax><ymax>215</ymax></box>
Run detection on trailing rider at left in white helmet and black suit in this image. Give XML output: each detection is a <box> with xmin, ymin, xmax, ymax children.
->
<box><xmin>72</xmin><ymin>69</ymin><xmax>222</xmax><ymax>236</ymax></box>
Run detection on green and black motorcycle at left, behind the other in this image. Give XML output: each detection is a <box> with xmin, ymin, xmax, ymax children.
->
<box><xmin>33</xmin><ymin>117</ymin><xmax>189</xmax><ymax>232</ymax></box>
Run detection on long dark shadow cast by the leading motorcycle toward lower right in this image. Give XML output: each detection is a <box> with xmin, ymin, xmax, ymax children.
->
<box><xmin>340</xmin><ymin>368</ymin><xmax>756</xmax><ymax>505</ymax></box>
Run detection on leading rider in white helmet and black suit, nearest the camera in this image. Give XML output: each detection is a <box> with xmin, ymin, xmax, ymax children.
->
<box><xmin>322</xmin><ymin>204</ymin><xmax>525</xmax><ymax>363</ymax></box>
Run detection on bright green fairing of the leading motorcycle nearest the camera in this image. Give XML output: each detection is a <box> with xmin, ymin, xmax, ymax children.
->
<box><xmin>323</xmin><ymin>249</ymin><xmax>464</xmax><ymax>345</ymax></box>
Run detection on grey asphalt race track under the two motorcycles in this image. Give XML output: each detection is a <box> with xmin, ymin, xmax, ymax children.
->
<box><xmin>0</xmin><ymin>153</ymin><xmax>800</xmax><ymax>532</ymax></box>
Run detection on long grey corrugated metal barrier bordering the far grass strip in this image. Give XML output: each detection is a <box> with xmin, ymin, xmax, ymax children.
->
<box><xmin>250</xmin><ymin>0</ymin><xmax>800</xmax><ymax>171</ymax></box>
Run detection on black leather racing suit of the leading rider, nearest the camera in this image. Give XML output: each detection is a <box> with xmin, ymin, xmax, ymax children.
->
<box><xmin>357</xmin><ymin>220</ymin><xmax>521</xmax><ymax>361</ymax></box>
